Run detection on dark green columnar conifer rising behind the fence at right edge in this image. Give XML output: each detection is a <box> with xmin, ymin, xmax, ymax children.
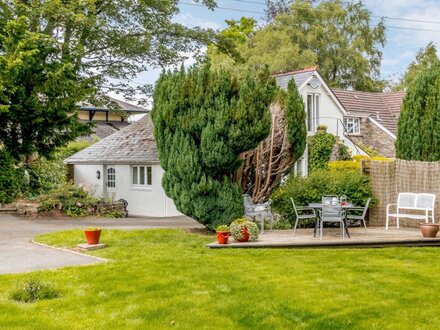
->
<box><xmin>396</xmin><ymin>62</ymin><xmax>440</xmax><ymax>161</ymax></box>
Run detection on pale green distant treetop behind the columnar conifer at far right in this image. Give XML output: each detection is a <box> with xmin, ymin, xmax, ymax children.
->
<box><xmin>393</xmin><ymin>41</ymin><xmax>439</xmax><ymax>90</ymax></box>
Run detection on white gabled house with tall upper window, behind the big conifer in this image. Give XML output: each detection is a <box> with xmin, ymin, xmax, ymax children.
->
<box><xmin>274</xmin><ymin>67</ymin><xmax>365</xmax><ymax>175</ymax></box>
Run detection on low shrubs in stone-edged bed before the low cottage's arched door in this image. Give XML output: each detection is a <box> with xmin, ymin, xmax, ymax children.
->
<box><xmin>38</xmin><ymin>183</ymin><xmax>98</xmax><ymax>217</ymax></box>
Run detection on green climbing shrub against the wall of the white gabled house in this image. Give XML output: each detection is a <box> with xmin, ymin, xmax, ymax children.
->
<box><xmin>308</xmin><ymin>130</ymin><xmax>336</xmax><ymax>172</ymax></box>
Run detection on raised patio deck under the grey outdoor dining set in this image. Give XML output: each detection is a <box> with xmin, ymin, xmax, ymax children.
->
<box><xmin>207</xmin><ymin>227</ymin><xmax>440</xmax><ymax>249</ymax></box>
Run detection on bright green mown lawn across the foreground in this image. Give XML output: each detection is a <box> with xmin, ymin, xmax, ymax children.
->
<box><xmin>0</xmin><ymin>230</ymin><xmax>440</xmax><ymax>329</ymax></box>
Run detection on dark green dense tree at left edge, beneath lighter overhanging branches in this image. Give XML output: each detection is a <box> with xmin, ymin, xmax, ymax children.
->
<box><xmin>0</xmin><ymin>17</ymin><xmax>90</xmax><ymax>159</ymax></box>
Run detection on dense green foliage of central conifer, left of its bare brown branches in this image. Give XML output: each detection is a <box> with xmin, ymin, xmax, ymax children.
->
<box><xmin>152</xmin><ymin>63</ymin><xmax>276</xmax><ymax>229</ymax></box>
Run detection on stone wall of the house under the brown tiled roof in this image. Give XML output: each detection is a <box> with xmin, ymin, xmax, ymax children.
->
<box><xmin>350</xmin><ymin>118</ymin><xmax>396</xmax><ymax>158</ymax></box>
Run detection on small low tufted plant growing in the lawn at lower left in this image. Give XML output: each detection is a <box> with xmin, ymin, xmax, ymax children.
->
<box><xmin>11</xmin><ymin>278</ymin><xmax>60</xmax><ymax>303</ymax></box>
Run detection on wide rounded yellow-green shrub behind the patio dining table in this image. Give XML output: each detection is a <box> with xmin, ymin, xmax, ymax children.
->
<box><xmin>272</xmin><ymin>170</ymin><xmax>376</xmax><ymax>223</ymax></box>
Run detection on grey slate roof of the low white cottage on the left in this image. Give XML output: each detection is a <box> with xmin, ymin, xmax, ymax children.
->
<box><xmin>64</xmin><ymin>114</ymin><xmax>159</xmax><ymax>165</ymax></box>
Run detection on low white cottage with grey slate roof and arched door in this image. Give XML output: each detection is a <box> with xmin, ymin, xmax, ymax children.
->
<box><xmin>64</xmin><ymin>114</ymin><xmax>181</xmax><ymax>217</ymax></box>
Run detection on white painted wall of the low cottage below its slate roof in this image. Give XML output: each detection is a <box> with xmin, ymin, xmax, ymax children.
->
<box><xmin>74</xmin><ymin>164</ymin><xmax>182</xmax><ymax>217</ymax></box>
